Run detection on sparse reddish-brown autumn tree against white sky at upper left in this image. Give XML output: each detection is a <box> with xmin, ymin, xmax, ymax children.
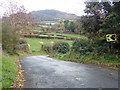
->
<box><xmin>3</xmin><ymin>0</ymin><xmax>33</xmax><ymax>33</ymax></box>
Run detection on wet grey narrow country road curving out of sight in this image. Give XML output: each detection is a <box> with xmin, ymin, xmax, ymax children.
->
<box><xmin>20</xmin><ymin>56</ymin><xmax>118</xmax><ymax>88</ymax></box>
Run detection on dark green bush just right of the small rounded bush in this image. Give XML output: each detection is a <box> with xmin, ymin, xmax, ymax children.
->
<box><xmin>71</xmin><ymin>39</ymin><xmax>92</xmax><ymax>54</ymax></box>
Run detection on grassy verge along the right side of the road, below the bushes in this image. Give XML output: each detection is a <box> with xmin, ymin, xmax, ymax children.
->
<box><xmin>50</xmin><ymin>52</ymin><xmax>120</xmax><ymax>69</ymax></box>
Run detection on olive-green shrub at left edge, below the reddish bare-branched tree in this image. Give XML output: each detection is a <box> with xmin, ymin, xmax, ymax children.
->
<box><xmin>2</xmin><ymin>22</ymin><xmax>19</xmax><ymax>54</ymax></box>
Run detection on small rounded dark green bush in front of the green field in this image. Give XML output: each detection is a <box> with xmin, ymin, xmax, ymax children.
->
<box><xmin>52</xmin><ymin>42</ymin><xmax>70</xmax><ymax>53</ymax></box>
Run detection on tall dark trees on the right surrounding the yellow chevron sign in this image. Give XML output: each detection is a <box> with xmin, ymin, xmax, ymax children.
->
<box><xmin>64</xmin><ymin>0</ymin><xmax>120</xmax><ymax>54</ymax></box>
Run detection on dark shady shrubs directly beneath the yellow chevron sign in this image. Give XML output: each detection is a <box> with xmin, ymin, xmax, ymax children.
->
<box><xmin>90</xmin><ymin>38</ymin><xmax>119</xmax><ymax>54</ymax></box>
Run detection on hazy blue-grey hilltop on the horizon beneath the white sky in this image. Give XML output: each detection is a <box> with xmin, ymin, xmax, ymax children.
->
<box><xmin>31</xmin><ymin>10</ymin><xmax>78</xmax><ymax>22</ymax></box>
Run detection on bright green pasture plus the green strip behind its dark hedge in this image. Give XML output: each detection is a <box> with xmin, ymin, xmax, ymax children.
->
<box><xmin>26</xmin><ymin>33</ymin><xmax>88</xmax><ymax>51</ymax></box>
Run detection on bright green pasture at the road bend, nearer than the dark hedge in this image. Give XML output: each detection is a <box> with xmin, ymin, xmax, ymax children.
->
<box><xmin>26</xmin><ymin>38</ymin><xmax>73</xmax><ymax>54</ymax></box>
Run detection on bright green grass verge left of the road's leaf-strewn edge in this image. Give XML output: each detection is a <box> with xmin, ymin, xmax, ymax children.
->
<box><xmin>2</xmin><ymin>54</ymin><xmax>17</xmax><ymax>88</ymax></box>
